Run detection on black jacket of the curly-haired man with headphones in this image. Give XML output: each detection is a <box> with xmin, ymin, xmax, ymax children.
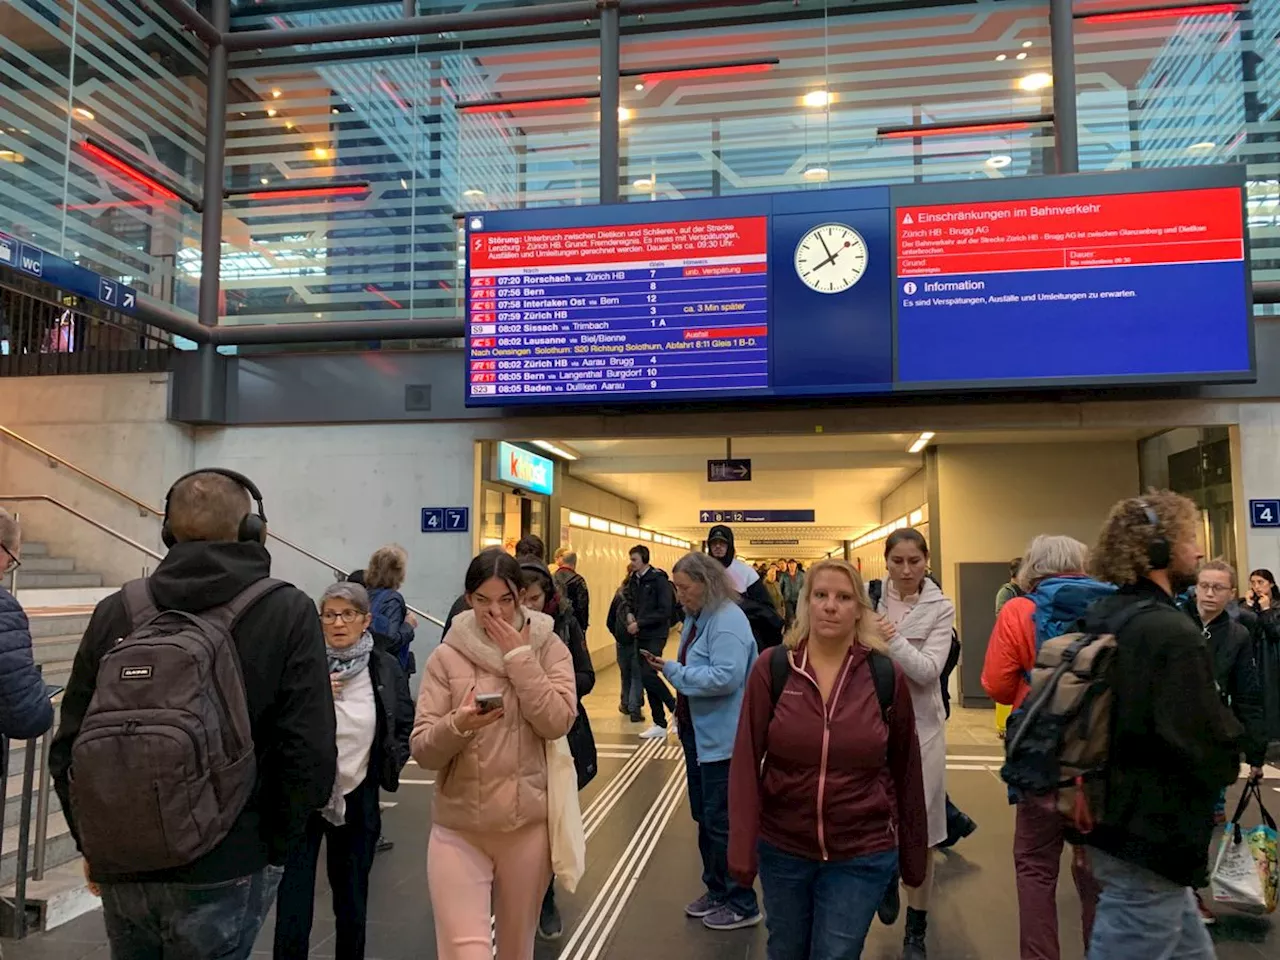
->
<box><xmin>1083</xmin><ymin>580</ymin><xmax>1242</xmax><ymax>887</ymax></box>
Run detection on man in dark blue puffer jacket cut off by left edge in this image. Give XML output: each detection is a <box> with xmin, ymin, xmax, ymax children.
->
<box><xmin>0</xmin><ymin>507</ymin><xmax>54</xmax><ymax>740</ymax></box>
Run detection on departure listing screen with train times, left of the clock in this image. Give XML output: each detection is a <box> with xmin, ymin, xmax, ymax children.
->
<box><xmin>467</xmin><ymin>216</ymin><xmax>769</xmax><ymax>402</ymax></box>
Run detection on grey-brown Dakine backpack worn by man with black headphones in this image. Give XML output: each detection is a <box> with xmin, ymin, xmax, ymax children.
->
<box><xmin>70</xmin><ymin>579</ymin><xmax>284</xmax><ymax>873</ymax></box>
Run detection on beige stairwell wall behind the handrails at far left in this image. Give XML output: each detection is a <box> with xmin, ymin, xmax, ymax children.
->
<box><xmin>0</xmin><ymin>374</ymin><xmax>195</xmax><ymax>586</ymax></box>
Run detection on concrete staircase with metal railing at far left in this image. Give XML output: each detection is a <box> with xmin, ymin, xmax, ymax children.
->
<box><xmin>0</xmin><ymin>543</ymin><xmax>115</xmax><ymax>931</ymax></box>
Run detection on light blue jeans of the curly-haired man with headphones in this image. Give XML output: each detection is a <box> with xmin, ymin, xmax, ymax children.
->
<box><xmin>1089</xmin><ymin>849</ymin><xmax>1215</xmax><ymax>960</ymax></box>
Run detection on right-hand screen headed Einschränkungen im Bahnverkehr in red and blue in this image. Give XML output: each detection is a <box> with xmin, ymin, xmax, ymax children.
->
<box><xmin>895</xmin><ymin>187</ymin><xmax>1252</xmax><ymax>388</ymax></box>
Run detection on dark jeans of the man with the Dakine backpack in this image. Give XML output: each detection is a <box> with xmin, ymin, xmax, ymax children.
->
<box><xmin>102</xmin><ymin>867</ymin><xmax>284</xmax><ymax>960</ymax></box>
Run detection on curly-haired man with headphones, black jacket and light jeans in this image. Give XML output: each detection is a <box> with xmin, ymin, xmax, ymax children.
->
<box><xmin>1083</xmin><ymin>490</ymin><xmax>1243</xmax><ymax>960</ymax></box>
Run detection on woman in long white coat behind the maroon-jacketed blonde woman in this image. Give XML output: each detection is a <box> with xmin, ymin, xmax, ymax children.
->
<box><xmin>878</xmin><ymin>527</ymin><xmax>956</xmax><ymax>960</ymax></box>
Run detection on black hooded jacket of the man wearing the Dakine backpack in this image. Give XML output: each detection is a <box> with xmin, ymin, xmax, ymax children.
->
<box><xmin>49</xmin><ymin>543</ymin><xmax>338</xmax><ymax>883</ymax></box>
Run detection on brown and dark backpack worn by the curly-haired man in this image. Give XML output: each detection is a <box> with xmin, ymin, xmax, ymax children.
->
<box><xmin>1000</xmin><ymin>600</ymin><xmax>1155</xmax><ymax>835</ymax></box>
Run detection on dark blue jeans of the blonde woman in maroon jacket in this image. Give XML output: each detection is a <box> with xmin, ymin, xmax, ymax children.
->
<box><xmin>759</xmin><ymin>840</ymin><xmax>897</xmax><ymax>960</ymax></box>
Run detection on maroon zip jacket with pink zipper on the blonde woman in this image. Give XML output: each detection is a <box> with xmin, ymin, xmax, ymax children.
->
<box><xmin>728</xmin><ymin>644</ymin><xmax>929</xmax><ymax>886</ymax></box>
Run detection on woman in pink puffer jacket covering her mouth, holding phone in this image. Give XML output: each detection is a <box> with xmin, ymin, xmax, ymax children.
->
<box><xmin>410</xmin><ymin>550</ymin><xmax>577</xmax><ymax>960</ymax></box>
